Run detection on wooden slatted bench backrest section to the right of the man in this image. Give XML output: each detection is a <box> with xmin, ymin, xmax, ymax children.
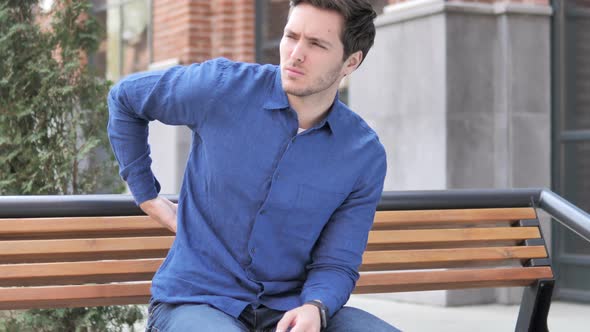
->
<box><xmin>355</xmin><ymin>208</ymin><xmax>553</xmax><ymax>293</ymax></box>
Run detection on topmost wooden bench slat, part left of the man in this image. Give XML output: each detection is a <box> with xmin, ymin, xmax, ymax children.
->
<box><xmin>0</xmin><ymin>216</ymin><xmax>172</xmax><ymax>240</ymax></box>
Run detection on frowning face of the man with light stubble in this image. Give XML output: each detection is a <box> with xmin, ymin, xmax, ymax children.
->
<box><xmin>280</xmin><ymin>3</ymin><xmax>345</xmax><ymax>97</ymax></box>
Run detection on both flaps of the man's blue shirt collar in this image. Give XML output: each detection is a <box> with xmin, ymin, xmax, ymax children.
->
<box><xmin>263</xmin><ymin>66</ymin><xmax>345</xmax><ymax>134</ymax></box>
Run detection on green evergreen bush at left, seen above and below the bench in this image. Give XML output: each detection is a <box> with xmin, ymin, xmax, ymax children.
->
<box><xmin>0</xmin><ymin>0</ymin><xmax>143</xmax><ymax>332</ymax></box>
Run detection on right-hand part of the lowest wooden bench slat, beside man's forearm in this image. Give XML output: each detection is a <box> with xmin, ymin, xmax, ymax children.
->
<box><xmin>354</xmin><ymin>266</ymin><xmax>553</xmax><ymax>294</ymax></box>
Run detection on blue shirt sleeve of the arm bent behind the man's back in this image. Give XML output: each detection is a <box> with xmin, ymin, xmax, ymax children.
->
<box><xmin>107</xmin><ymin>60</ymin><xmax>227</xmax><ymax>204</ymax></box>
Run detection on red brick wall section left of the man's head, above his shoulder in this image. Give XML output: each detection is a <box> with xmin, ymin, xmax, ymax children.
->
<box><xmin>153</xmin><ymin>0</ymin><xmax>255</xmax><ymax>64</ymax></box>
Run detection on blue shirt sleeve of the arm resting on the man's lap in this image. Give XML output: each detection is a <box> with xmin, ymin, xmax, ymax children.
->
<box><xmin>301</xmin><ymin>143</ymin><xmax>387</xmax><ymax>316</ymax></box>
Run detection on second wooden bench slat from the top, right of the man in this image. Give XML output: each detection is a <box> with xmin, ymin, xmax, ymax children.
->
<box><xmin>368</xmin><ymin>227</ymin><xmax>541</xmax><ymax>249</ymax></box>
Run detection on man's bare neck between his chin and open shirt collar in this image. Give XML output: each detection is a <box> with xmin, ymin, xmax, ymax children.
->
<box><xmin>287</xmin><ymin>91</ymin><xmax>336</xmax><ymax>129</ymax></box>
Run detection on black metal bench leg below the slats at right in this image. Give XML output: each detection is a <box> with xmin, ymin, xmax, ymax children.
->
<box><xmin>516</xmin><ymin>280</ymin><xmax>555</xmax><ymax>332</ymax></box>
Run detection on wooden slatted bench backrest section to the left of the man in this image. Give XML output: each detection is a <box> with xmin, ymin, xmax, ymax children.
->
<box><xmin>0</xmin><ymin>216</ymin><xmax>174</xmax><ymax>309</ymax></box>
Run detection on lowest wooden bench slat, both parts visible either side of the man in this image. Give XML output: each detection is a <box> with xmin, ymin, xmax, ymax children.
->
<box><xmin>0</xmin><ymin>267</ymin><xmax>553</xmax><ymax>310</ymax></box>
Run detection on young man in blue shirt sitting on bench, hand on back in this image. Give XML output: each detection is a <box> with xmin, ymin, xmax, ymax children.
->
<box><xmin>108</xmin><ymin>0</ymin><xmax>396</xmax><ymax>332</ymax></box>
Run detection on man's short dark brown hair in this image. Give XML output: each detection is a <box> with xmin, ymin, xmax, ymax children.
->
<box><xmin>289</xmin><ymin>0</ymin><xmax>377</xmax><ymax>63</ymax></box>
